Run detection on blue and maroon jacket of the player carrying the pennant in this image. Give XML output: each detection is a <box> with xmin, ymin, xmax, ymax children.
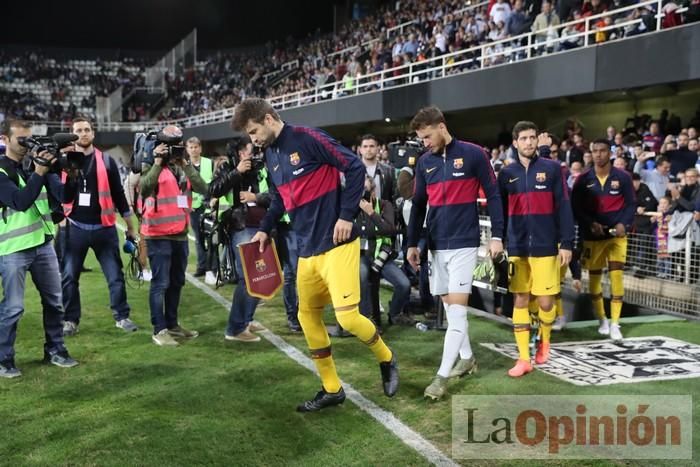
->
<box><xmin>260</xmin><ymin>124</ymin><xmax>365</xmax><ymax>258</ymax></box>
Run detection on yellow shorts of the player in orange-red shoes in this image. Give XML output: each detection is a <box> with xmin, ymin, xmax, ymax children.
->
<box><xmin>508</xmin><ymin>256</ymin><xmax>560</xmax><ymax>296</ymax></box>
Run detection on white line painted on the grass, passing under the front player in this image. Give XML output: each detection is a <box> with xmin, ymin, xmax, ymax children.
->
<box><xmin>187</xmin><ymin>273</ymin><xmax>459</xmax><ymax>467</ymax></box>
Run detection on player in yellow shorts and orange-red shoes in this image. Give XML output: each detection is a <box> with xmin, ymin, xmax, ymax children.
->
<box><xmin>498</xmin><ymin>121</ymin><xmax>574</xmax><ymax>378</ymax></box>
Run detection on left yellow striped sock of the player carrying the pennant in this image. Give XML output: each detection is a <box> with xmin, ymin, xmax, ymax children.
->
<box><xmin>298</xmin><ymin>307</ymin><xmax>340</xmax><ymax>393</ymax></box>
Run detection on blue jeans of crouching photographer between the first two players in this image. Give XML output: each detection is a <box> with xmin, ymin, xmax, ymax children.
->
<box><xmin>360</xmin><ymin>255</ymin><xmax>411</xmax><ymax>317</ymax></box>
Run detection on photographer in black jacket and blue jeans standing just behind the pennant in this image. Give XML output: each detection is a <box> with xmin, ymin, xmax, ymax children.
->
<box><xmin>209</xmin><ymin>135</ymin><xmax>270</xmax><ymax>342</ymax></box>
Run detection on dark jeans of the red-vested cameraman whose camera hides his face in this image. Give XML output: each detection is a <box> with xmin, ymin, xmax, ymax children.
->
<box><xmin>146</xmin><ymin>239</ymin><xmax>190</xmax><ymax>334</ymax></box>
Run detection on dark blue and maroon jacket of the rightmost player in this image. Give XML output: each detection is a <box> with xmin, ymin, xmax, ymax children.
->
<box><xmin>571</xmin><ymin>167</ymin><xmax>637</xmax><ymax>240</ymax></box>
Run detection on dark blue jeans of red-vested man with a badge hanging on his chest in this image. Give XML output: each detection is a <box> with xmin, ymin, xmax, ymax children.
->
<box><xmin>62</xmin><ymin>221</ymin><xmax>131</xmax><ymax>323</ymax></box>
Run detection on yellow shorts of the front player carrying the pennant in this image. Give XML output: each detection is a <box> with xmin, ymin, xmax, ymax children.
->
<box><xmin>297</xmin><ymin>238</ymin><xmax>360</xmax><ymax>308</ymax></box>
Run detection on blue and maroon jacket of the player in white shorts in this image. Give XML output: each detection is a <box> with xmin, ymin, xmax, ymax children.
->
<box><xmin>407</xmin><ymin>139</ymin><xmax>503</xmax><ymax>250</ymax></box>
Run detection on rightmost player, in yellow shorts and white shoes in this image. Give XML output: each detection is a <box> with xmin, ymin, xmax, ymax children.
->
<box><xmin>571</xmin><ymin>139</ymin><xmax>636</xmax><ymax>340</ymax></box>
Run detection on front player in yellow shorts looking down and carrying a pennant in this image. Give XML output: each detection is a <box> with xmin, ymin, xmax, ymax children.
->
<box><xmin>232</xmin><ymin>98</ymin><xmax>399</xmax><ymax>412</ymax></box>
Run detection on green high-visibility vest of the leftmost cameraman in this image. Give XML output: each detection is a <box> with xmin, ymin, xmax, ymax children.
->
<box><xmin>0</xmin><ymin>169</ymin><xmax>54</xmax><ymax>256</ymax></box>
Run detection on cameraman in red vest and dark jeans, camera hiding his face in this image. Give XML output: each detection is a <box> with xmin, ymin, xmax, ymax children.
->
<box><xmin>141</xmin><ymin>125</ymin><xmax>209</xmax><ymax>346</ymax></box>
